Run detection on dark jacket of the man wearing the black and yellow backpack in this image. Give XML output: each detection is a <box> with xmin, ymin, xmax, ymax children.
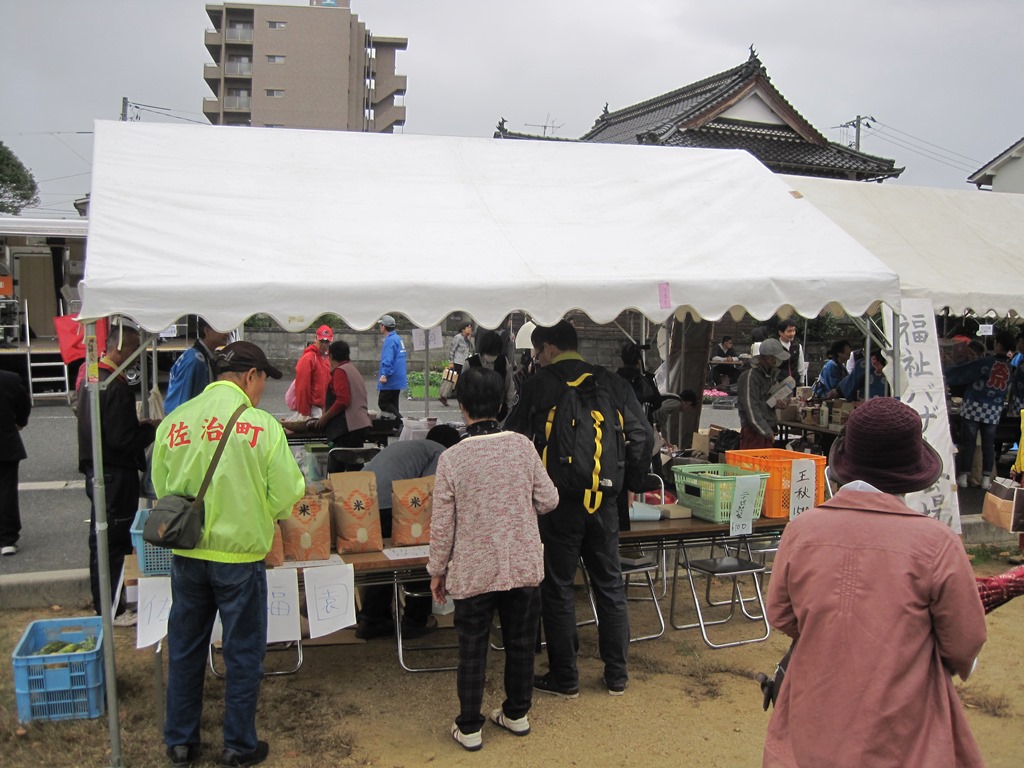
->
<box><xmin>505</xmin><ymin>356</ymin><xmax>654</xmax><ymax>493</ymax></box>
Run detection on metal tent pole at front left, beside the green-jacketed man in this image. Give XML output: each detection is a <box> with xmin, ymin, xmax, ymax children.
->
<box><xmin>85</xmin><ymin>323</ymin><xmax>124</xmax><ymax>768</ymax></box>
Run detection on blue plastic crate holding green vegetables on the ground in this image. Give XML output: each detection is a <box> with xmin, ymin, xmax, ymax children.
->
<box><xmin>12</xmin><ymin>616</ymin><xmax>105</xmax><ymax>723</ymax></box>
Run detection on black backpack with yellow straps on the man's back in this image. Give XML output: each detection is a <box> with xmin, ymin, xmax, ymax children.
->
<box><xmin>539</xmin><ymin>369</ymin><xmax>626</xmax><ymax>514</ymax></box>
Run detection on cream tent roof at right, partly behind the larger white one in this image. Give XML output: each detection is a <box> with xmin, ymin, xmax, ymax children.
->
<box><xmin>782</xmin><ymin>176</ymin><xmax>1024</xmax><ymax>315</ymax></box>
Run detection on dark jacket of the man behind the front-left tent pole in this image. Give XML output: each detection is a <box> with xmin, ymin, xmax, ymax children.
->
<box><xmin>78</xmin><ymin>364</ymin><xmax>157</xmax><ymax>473</ymax></box>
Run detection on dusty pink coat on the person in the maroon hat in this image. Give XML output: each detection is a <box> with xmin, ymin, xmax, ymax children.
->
<box><xmin>764</xmin><ymin>490</ymin><xmax>985</xmax><ymax>768</ymax></box>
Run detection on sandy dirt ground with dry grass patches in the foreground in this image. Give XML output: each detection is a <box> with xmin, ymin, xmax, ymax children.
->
<box><xmin>0</xmin><ymin>557</ymin><xmax>1024</xmax><ymax>768</ymax></box>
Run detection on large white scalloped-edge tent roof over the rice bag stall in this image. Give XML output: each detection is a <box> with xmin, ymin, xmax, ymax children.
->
<box><xmin>82</xmin><ymin>122</ymin><xmax>899</xmax><ymax>331</ymax></box>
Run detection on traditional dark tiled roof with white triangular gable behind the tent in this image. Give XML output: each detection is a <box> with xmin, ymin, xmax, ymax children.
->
<box><xmin>495</xmin><ymin>47</ymin><xmax>903</xmax><ymax>181</ymax></box>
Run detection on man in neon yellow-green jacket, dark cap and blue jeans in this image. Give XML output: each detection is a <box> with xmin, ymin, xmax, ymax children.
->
<box><xmin>153</xmin><ymin>341</ymin><xmax>305</xmax><ymax>766</ymax></box>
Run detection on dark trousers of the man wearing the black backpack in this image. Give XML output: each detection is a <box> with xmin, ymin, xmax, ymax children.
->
<box><xmin>538</xmin><ymin>497</ymin><xmax>630</xmax><ymax>688</ymax></box>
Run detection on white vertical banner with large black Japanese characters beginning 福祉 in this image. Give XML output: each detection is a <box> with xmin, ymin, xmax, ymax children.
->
<box><xmin>884</xmin><ymin>298</ymin><xmax>961</xmax><ymax>534</ymax></box>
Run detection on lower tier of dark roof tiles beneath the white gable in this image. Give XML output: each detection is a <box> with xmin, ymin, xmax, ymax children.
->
<box><xmin>660</xmin><ymin>118</ymin><xmax>903</xmax><ymax>180</ymax></box>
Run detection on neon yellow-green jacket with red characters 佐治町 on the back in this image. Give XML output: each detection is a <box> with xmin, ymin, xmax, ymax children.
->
<box><xmin>153</xmin><ymin>381</ymin><xmax>305</xmax><ymax>562</ymax></box>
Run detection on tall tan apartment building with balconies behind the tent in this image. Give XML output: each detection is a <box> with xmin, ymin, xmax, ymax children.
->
<box><xmin>203</xmin><ymin>0</ymin><xmax>409</xmax><ymax>133</ymax></box>
